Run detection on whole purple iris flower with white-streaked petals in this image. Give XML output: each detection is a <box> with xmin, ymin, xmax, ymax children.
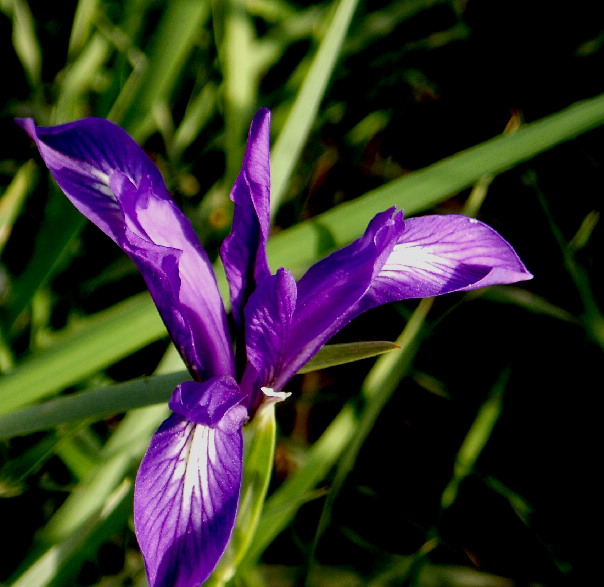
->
<box><xmin>18</xmin><ymin>109</ymin><xmax>532</xmax><ymax>587</ymax></box>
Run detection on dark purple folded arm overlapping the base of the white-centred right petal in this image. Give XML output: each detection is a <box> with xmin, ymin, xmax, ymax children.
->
<box><xmin>275</xmin><ymin>208</ymin><xmax>403</xmax><ymax>390</ymax></box>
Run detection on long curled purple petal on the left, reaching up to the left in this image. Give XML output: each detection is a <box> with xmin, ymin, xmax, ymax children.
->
<box><xmin>19</xmin><ymin>118</ymin><xmax>234</xmax><ymax>378</ymax></box>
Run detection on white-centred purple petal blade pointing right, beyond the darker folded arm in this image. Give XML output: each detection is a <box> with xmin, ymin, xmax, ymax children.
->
<box><xmin>363</xmin><ymin>215</ymin><xmax>532</xmax><ymax>309</ymax></box>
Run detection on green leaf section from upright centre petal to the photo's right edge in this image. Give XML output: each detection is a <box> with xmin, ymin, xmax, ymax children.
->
<box><xmin>269</xmin><ymin>94</ymin><xmax>604</xmax><ymax>270</ymax></box>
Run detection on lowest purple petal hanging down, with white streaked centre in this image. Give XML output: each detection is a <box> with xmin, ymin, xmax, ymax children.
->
<box><xmin>134</xmin><ymin>381</ymin><xmax>247</xmax><ymax>587</ymax></box>
